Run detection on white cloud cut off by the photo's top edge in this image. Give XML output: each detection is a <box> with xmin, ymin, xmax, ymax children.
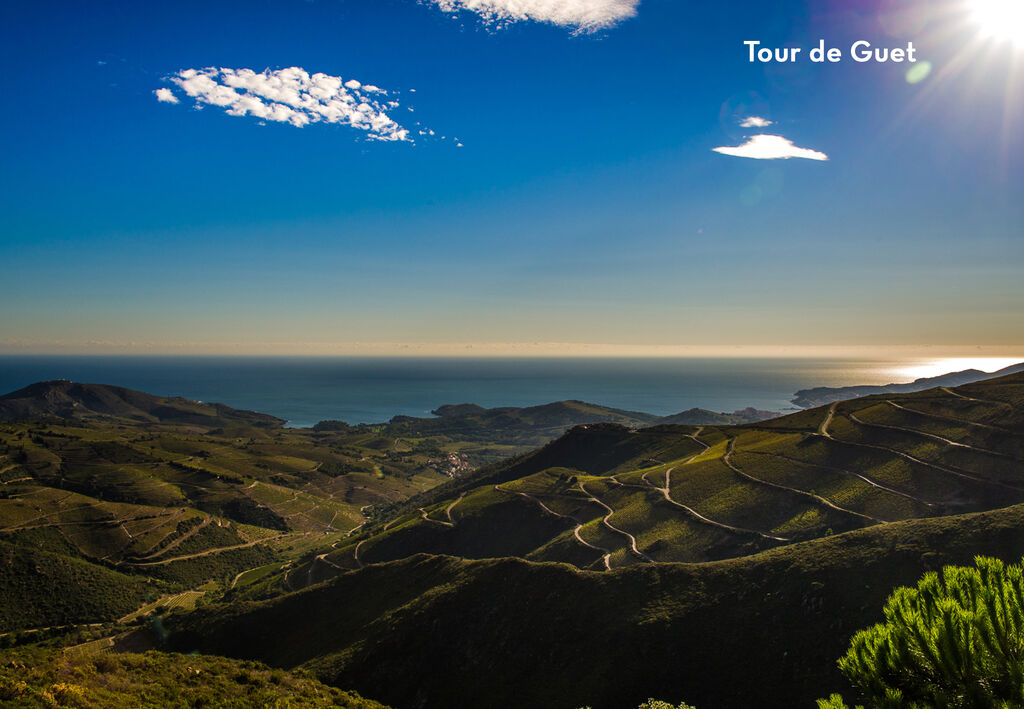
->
<box><xmin>424</xmin><ymin>0</ymin><xmax>640</xmax><ymax>33</ymax></box>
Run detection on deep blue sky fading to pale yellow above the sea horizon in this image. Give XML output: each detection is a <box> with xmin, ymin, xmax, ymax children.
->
<box><xmin>0</xmin><ymin>0</ymin><xmax>1024</xmax><ymax>353</ymax></box>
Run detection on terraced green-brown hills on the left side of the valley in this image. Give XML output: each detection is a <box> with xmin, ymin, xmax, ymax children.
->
<box><xmin>0</xmin><ymin>382</ymin><xmax>447</xmax><ymax>631</ymax></box>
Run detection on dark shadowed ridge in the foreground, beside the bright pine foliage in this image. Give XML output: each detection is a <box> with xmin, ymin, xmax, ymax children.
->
<box><xmin>172</xmin><ymin>506</ymin><xmax>1024</xmax><ymax>709</ymax></box>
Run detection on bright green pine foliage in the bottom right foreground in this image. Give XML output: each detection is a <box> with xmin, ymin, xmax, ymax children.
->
<box><xmin>818</xmin><ymin>556</ymin><xmax>1024</xmax><ymax>709</ymax></box>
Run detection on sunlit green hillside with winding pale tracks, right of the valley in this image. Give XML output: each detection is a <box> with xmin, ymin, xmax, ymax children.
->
<box><xmin>270</xmin><ymin>374</ymin><xmax>1024</xmax><ymax>580</ymax></box>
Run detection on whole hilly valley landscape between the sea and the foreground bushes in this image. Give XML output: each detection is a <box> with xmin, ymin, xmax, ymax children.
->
<box><xmin>0</xmin><ymin>374</ymin><xmax>1024</xmax><ymax>709</ymax></box>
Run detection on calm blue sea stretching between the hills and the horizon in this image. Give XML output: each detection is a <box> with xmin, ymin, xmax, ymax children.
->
<box><xmin>0</xmin><ymin>355</ymin><xmax>937</xmax><ymax>426</ymax></box>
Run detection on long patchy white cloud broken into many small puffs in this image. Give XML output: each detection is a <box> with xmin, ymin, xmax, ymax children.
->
<box><xmin>155</xmin><ymin>67</ymin><xmax>410</xmax><ymax>140</ymax></box>
